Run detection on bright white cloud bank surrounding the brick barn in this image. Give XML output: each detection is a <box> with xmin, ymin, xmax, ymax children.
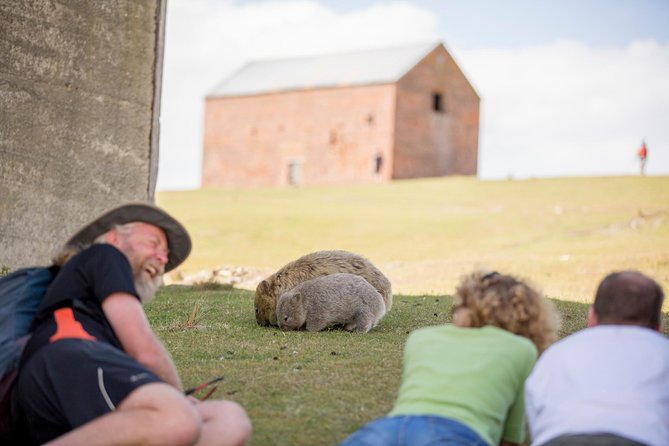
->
<box><xmin>158</xmin><ymin>0</ymin><xmax>669</xmax><ymax>190</ymax></box>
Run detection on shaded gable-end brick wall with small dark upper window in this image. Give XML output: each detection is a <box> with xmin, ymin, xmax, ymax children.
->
<box><xmin>393</xmin><ymin>46</ymin><xmax>480</xmax><ymax>178</ymax></box>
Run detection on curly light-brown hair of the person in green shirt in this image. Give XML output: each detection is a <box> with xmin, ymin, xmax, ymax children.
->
<box><xmin>453</xmin><ymin>271</ymin><xmax>561</xmax><ymax>353</ymax></box>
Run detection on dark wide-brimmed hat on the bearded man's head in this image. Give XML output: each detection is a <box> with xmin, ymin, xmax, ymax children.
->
<box><xmin>65</xmin><ymin>203</ymin><xmax>191</xmax><ymax>272</ymax></box>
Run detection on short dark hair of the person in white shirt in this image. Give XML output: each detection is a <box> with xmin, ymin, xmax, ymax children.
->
<box><xmin>593</xmin><ymin>271</ymin><xmax>664</xmax><ymax>329</ymax></box>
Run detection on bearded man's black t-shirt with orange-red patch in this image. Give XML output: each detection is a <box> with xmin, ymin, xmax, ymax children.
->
<box><xmin>22</xmin><ymin>244</ymin><xmax>139</xmax><ymax>363</ymax></box>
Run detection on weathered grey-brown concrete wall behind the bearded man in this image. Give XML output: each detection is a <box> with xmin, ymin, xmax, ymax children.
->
<box><xmin>0</xmin><ymin>0</ymin><xmax>165</xmax><ymax>269</ymax></box>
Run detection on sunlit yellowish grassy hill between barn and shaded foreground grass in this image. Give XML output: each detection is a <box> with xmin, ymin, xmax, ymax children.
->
<box><xmin>157</xmin><ymin>177</ymin><xmax>669</xmax><ymax>302</ymax></box>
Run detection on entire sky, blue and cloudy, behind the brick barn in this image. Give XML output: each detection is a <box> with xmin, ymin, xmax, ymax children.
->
<box><xmin>157</xmin><ymin>0</ymin><xmax>669</xmax><ymax>191</ymax></box>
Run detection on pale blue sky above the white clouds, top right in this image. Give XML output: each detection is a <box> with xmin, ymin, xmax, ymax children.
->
<box><xmin>330</xmin><ymin>0</ymin><xmax>669</xmax><ymax>48</ymax></box>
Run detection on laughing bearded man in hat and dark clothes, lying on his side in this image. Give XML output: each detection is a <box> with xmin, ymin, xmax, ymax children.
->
<box><xmin>12</xmin><ymin>203</ymin><xmax>251</xmax><ymax>446</ymax></box>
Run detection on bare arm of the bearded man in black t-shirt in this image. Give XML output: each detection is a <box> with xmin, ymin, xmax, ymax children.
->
<box><xmin>102</xmin><ymin>293</ymin><xmax>183</xmax><ymax>390</ymax></box>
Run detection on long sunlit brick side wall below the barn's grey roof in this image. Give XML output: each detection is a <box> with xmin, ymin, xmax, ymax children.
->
<box><xmin>202</xmin><ymin>85</ymin><xmax>395</xmax><ymax>186</ymax></box>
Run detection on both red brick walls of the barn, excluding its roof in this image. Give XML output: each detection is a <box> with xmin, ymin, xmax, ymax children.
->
<box><xmin>202</xmin><ymin>46</ymin><xmax>479</xmax><ymax>186</ymax></box>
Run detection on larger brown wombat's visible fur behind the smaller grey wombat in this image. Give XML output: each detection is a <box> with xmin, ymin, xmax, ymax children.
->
<box><xmin>255</xmin><ymin>251</ymin><xmax>393</xmax><ymax>325</ymax></box>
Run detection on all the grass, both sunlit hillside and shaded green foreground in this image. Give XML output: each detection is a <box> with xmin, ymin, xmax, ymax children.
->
<box><xmin>154</xmin><ymin>177</ymin><xmax>669</xmax><ymax>446</ymax></box>
